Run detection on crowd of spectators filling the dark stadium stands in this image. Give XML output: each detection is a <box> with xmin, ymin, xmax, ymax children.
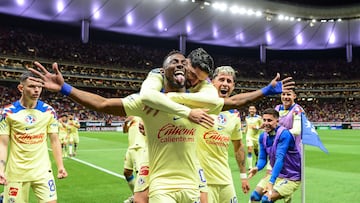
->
<box><xmin>0</xmin><ymin>21</ymin><xmax>360</xmax><ymax>122</ymax></box>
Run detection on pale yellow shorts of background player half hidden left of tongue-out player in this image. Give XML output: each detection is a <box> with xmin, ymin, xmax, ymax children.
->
<box><xmin>124</xmin><ymin>147</ymin><xmax>147</xmax><ymax>173</ymax></box>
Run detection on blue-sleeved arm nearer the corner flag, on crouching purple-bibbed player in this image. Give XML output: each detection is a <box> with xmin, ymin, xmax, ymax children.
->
<box><xmin>269</xmin><ymin>130</ymin><xmax>295</xmax><ymax>185</ymax></box>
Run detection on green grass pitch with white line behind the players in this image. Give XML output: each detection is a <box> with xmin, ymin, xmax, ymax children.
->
<box><xmin>1</xmin><ymin>130</ymin><xmax>360</xmax><ymax>203</ymax></box>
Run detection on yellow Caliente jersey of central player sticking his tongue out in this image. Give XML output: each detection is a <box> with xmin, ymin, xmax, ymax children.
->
<box><xmin>122</xmin><ymin>94</ymin><xmax>203</xmax><ymax>197</ymax></box>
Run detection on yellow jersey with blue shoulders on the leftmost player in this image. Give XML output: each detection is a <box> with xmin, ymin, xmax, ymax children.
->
<box><xmin>0</xmin><ymin>101</ymin><xmax>59</xmax><ymax>182</ymax></box>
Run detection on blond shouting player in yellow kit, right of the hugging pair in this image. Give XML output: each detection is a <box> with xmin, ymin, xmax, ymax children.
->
<box><xmin>197</xmin><ymin>66</ymin><xmax>250</xmax><ymax>203</ymax></box>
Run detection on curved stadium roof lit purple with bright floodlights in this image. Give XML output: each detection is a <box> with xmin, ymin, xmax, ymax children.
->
<box><xmin>0</xmin><ymin>0</ymin><xmax>360</xmax><ymax>50</ymax></box>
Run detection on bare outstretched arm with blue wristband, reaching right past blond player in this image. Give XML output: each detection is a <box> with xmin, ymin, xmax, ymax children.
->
<box><xmin>223</xmin><ymin>73</ymin><xmax>295</xmax><ymax>110</ymax></box>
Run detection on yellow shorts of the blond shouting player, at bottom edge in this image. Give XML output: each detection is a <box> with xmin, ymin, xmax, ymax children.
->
<box><xmin>208</xmin><ymin>184</ymin><xmax>238</xmax><ymax>203</ymax></box>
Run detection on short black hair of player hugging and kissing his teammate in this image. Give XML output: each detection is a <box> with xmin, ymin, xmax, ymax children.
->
<box><xmin>187</xmin><ymin>48</ymin><xmax>214</xmax><ymax>75</ymax></box>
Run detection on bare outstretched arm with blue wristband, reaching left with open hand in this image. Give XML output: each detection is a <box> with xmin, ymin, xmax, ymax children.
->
<box><xmin>29</xmin><ymin>62</ymin><xmax>126</xmax><ymax>116</ymax></box>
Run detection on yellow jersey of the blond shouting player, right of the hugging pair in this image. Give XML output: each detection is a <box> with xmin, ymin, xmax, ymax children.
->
<box><xmin>197</xmin><ymin>110</ymin><xmax>242</xmax><ymax>185</ymax></box>
